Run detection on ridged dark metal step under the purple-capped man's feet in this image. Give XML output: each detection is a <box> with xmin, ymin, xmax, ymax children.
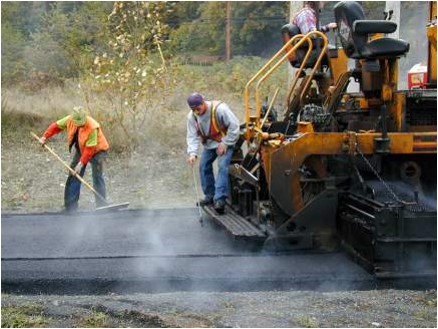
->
<box><xmin>203</xmin><ymin>205</ymin><xmax>267</xmax><ymax>240</ymax></box>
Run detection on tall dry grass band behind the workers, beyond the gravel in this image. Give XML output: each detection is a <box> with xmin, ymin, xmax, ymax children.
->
<box><xmin>2</xmin><ymin>57</ymin><xmax>287</xmax><ymax>152</ymax></box>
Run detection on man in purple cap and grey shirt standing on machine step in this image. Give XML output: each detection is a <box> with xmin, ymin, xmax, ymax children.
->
<box><xmin>187</xmin><ymin>93</ymin><xmax>240</xmax><ymax>214</ymax></box>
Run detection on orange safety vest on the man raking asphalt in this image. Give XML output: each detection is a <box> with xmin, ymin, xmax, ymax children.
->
<box><xmin>67</xmin><ymin>116</ymin><xmax>109</xmax><ymax>156</ymax></box>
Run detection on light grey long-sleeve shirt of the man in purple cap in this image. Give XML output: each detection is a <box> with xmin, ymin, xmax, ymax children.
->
<box><xmin>187</xmin><ymin>101</ymin><xmax>240</xmax><ymax>155</ymax></box>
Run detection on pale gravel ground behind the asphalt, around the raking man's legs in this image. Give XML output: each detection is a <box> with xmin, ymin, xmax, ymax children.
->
<box><xmin>1</xmin><ymin>136</ymin><xmax>196</xmax><ymax>213</ymax></box>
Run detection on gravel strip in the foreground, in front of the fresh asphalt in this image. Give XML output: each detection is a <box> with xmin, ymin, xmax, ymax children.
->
<box><xmin>2</xmin><ymin>290</ymin><xmax>437</xmax><ymax>328</ymax></box>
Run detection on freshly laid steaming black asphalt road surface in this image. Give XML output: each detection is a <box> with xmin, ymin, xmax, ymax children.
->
<box><xmin>1</xmin><ymin>208</ymin><xmax>374</xmax><ymax>293</ymax></box>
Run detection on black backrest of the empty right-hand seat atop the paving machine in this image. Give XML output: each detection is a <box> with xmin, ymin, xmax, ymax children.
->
<box><xmin>334</xmin><ymin>1</ymin><xmax>368</xmax><ymax>57</ymax></box>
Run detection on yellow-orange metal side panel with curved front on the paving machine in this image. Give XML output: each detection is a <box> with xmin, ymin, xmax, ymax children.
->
<box><xmin>263</xmin><ymin>132</ymin><xmax>437</xmax><ymax>214</ymax></box>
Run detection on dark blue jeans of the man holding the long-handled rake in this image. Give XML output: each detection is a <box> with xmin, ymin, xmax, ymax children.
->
<box><xmin>64</xmin><ymin>149</ymin><xmax>108</xmax><ymax>211</ymax></box>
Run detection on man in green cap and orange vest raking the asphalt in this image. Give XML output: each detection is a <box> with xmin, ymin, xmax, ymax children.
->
<box><xmin>40</xmin><ymin>106</ymin><xmax>109</xmax><ymax>213</ymax></box>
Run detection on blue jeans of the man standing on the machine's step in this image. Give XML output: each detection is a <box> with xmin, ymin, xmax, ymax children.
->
<box><xmin>199</xmin><ymin>147</ymin><xmax>233</xmax><ymax>201</ymax></box>
